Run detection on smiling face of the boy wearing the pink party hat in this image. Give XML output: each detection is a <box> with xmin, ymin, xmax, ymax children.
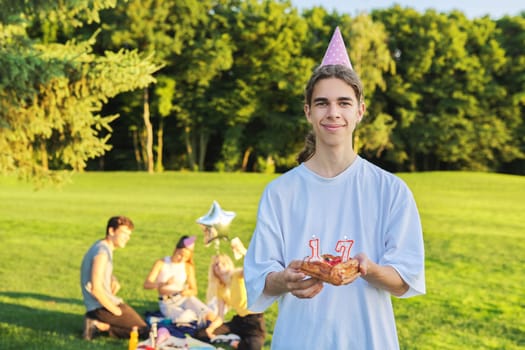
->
<box><xmin>304</xmin><ymin>78</ymin><xmax>365</xmax><ymax>147</ymax></box>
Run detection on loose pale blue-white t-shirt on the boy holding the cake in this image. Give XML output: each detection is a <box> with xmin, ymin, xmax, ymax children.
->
<box><xmin>244</xmin><ymin>157</ymin><xmax>425</xmax><ymax>350</ymax></box>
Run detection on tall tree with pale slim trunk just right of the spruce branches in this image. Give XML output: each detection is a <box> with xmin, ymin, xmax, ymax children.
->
<box><xmin>99</xmin><ymin>0</ymin><xmax>231</xmax><ymax>172</ymax></box>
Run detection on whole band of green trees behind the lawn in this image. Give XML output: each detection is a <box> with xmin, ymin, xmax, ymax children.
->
<box><xmin>0</xmin><ymin>0</ymin><xmax>525</xmax><ymax>179</ymax></box>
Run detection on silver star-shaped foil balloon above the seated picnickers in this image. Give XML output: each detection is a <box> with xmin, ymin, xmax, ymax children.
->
<box><xmin>197</xmin><ymin>201</ymin><xmax>235</xmax><ymax>245</ymax></box>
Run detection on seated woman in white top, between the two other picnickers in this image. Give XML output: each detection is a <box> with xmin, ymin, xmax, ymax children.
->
<box><xmin>144</xmin><ymin>236</ymin><xmax>222</xmax><ymax>335</ymax></box>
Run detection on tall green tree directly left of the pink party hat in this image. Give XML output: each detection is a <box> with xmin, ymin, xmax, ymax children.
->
<box><xmin>223</xmin><ymin>0</ymin><xmax>313</xmax><ymax>172</ymax></box>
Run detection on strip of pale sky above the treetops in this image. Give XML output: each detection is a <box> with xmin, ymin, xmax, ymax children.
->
<box><xmin>292</xmin><ymin>0</ymin><xmax>525</xmax><ymax>19</ymax></box>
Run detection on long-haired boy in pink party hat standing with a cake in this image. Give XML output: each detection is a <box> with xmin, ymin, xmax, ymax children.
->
<box><xmin>244</xmin><ymin>28</ymin><xmax>426</xmax><ymax>350</ymax></box>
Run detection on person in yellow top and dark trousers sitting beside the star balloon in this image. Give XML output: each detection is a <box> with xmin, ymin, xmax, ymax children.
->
<box><xmin>196</xmin><ymin>254</ymin><xmax>266</xmax><ymax>350</ymax></box>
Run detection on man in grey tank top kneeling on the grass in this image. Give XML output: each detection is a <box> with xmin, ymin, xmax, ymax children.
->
<box><xmin>80</xmin><ymin>216</ymin><xmax>148</xmax><ymax>340</ymax></box>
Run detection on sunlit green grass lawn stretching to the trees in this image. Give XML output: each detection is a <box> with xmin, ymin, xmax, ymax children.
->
<box><xmin>0</xmin><ymin>172</ymin><xmax>525</xmax><ymax>350</ymax></box>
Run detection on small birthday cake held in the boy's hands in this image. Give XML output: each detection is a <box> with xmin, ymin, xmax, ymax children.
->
<box><xmin>300</xmin><ymin>254</ymin><xmax>361</xmax><ymax>286</ymax></box>
